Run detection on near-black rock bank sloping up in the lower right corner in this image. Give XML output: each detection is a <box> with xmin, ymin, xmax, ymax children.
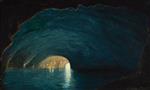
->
<box><xmin>100</xmin><ymin>36</ymin><xmax>150</xmax><ymax>90</ymax></box>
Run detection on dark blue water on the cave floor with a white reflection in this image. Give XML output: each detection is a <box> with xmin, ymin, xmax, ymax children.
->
<box><xmin>4</xmin><ymin>69</ymin><xmax>121</xmax><ymax>90</ymax></box>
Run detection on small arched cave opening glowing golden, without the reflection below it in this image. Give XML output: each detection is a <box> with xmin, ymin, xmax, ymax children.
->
<box><xmin>38</xmin><ymin>55</ymin><xmax>71</xmax><ymax>72</ymax></box>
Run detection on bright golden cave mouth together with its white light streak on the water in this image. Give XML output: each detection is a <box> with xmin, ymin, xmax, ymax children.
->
<box><xmin>39</xmin><ymin>56</ymin><xmax>72</xmax><ymax>88</ymax></box>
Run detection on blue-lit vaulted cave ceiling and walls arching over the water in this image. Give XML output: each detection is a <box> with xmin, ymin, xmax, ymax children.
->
<box><xmin>2</xmin><ymin>5</ymin><xmax>148</xmax><ymax>71</ymax></box>
